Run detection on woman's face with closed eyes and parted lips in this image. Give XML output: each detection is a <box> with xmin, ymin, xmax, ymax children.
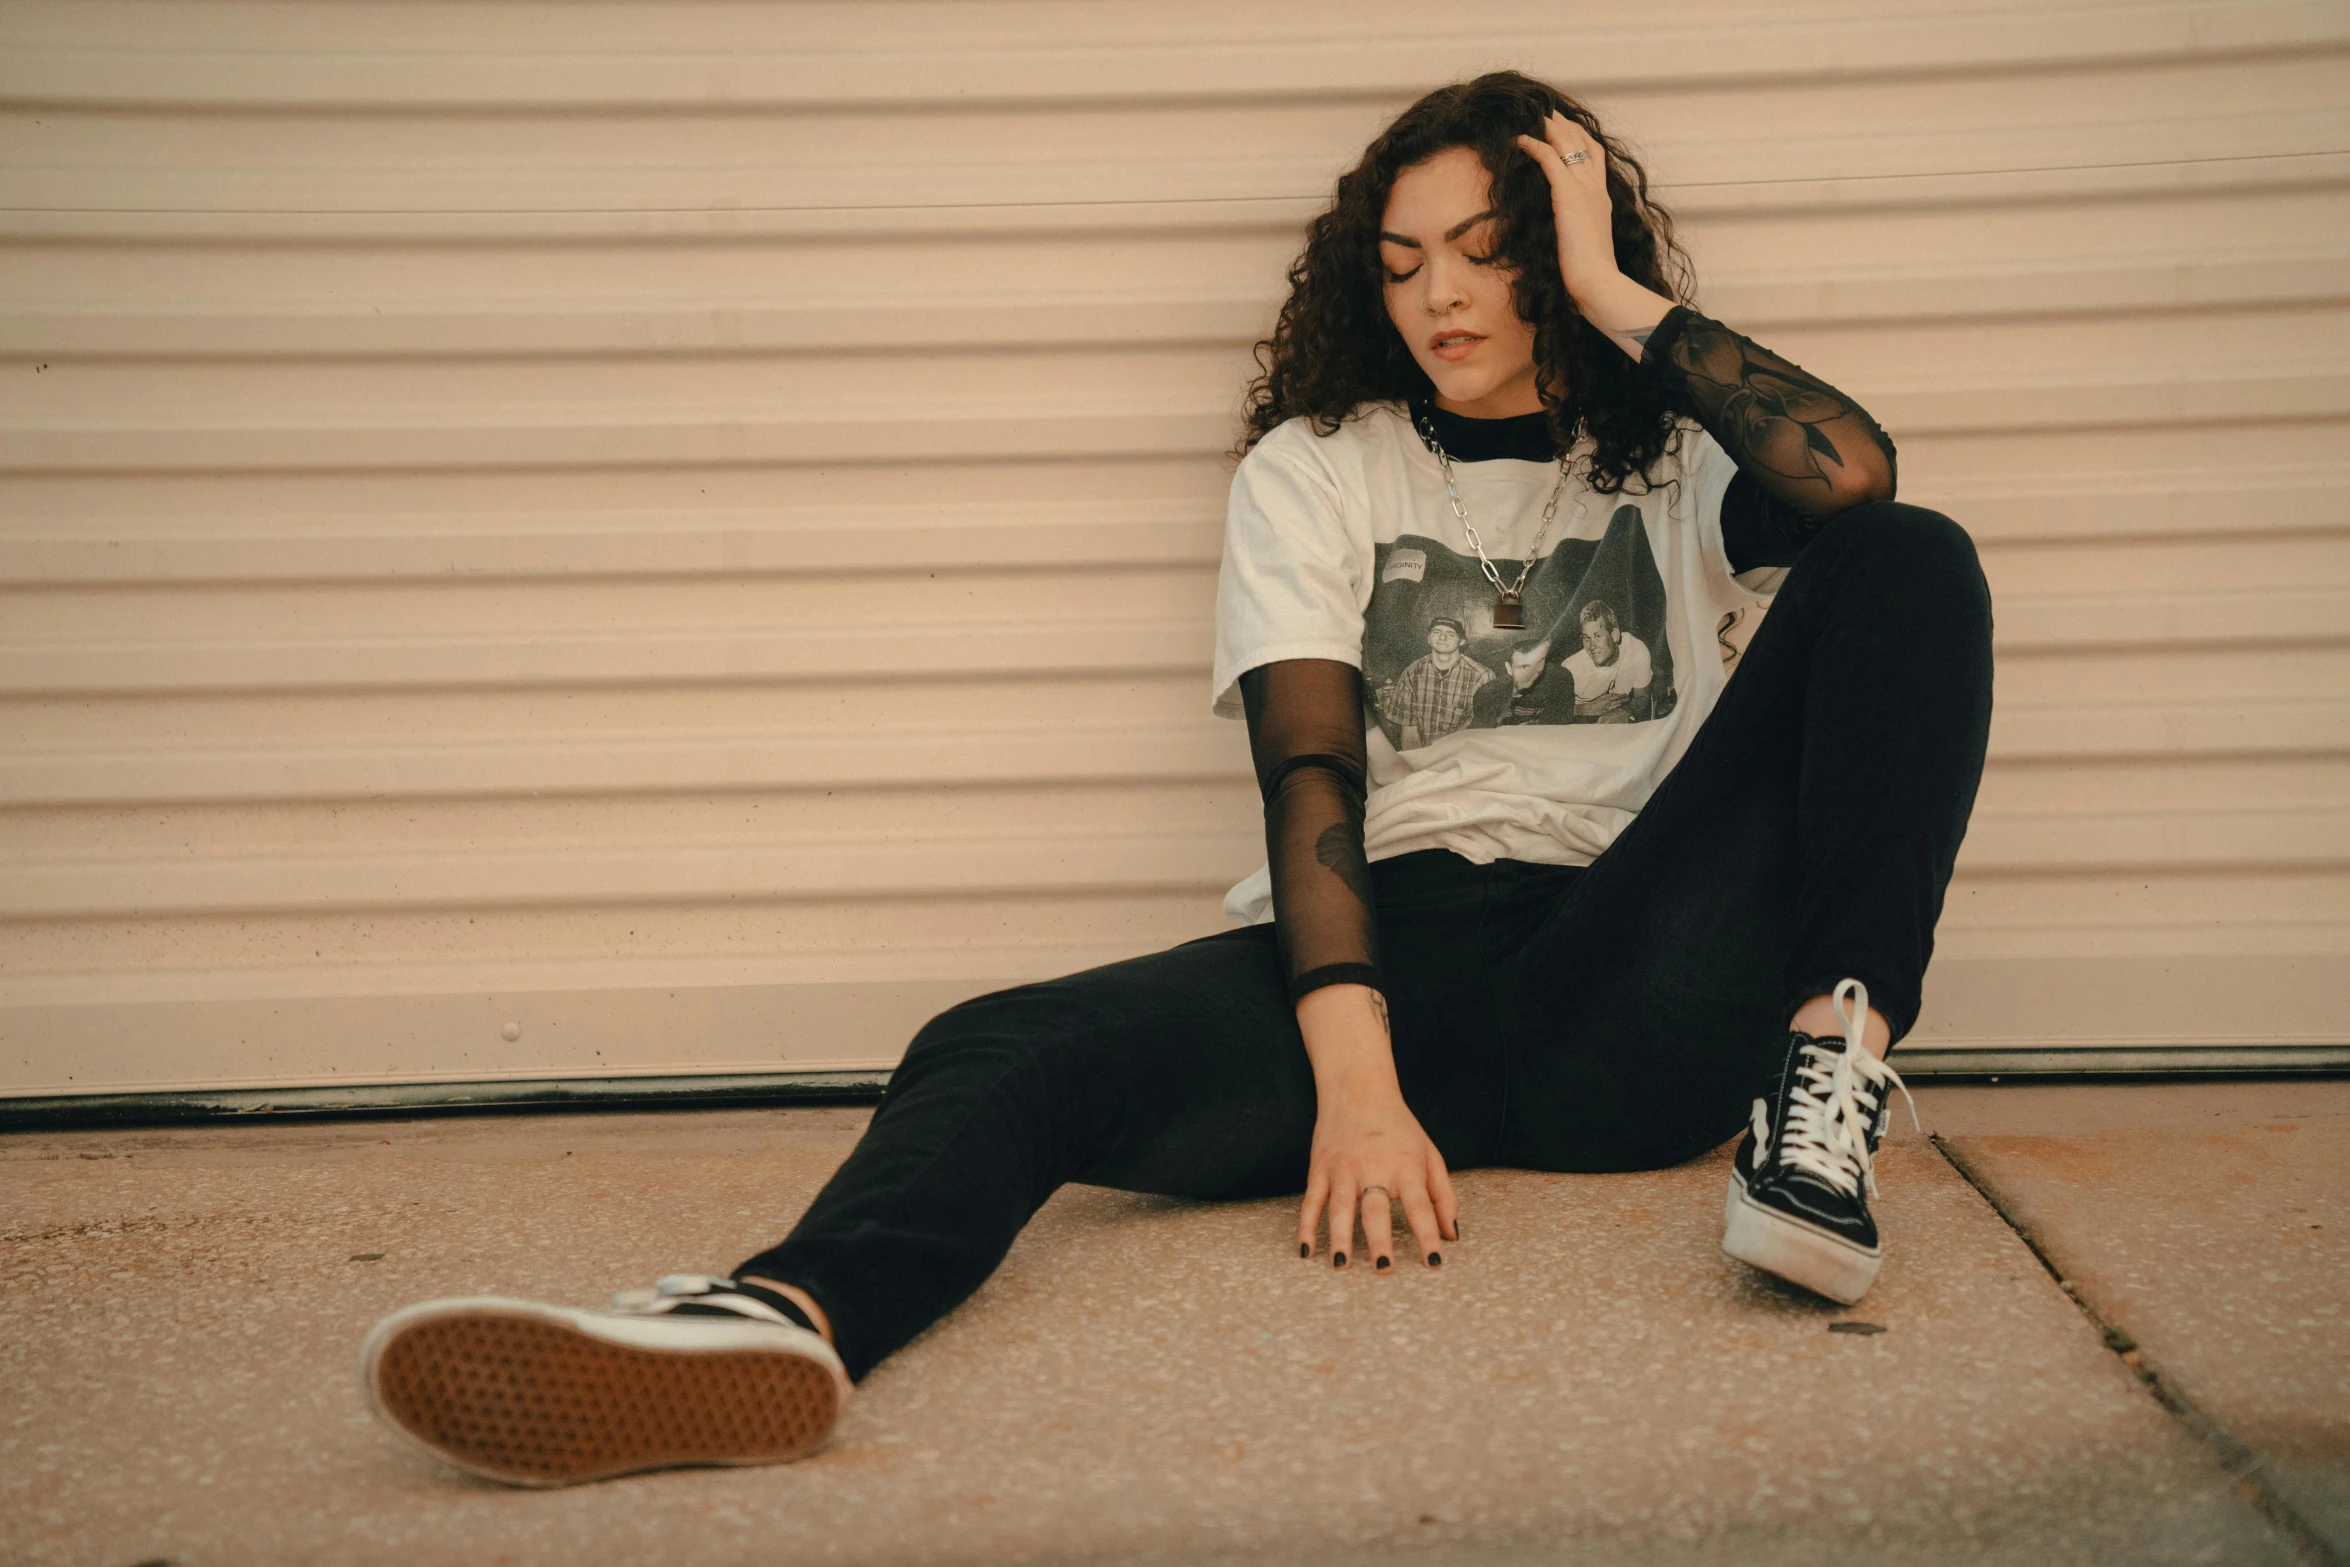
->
<box><xmin>1379</xmin><ymin>148</ymin><xmax>1542</xmax><ymax>418</ymax></box>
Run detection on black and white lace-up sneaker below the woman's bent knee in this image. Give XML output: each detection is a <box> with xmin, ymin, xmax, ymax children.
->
<box><xmin>1723</xmin><ymin>980</ymin><xmax>1918</xmax><ymax>1306</ymax></box>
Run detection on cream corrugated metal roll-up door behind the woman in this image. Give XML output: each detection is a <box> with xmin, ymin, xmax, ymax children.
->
<box><xmin>0</xmin><ymin>0</ymin><xmax>2350</xmax><ymax>1097</ymax></box>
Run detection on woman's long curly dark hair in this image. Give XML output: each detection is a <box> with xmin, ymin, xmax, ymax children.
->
<box><xmin>1234</xmin><ymin>70</ymin><xmax>1694</xmax><ymax>493</ymax></box>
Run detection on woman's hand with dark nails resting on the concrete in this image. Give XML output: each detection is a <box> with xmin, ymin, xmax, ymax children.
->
<box><xmin>1297</xmin><ymin>984</ymin><xmax>1459</xmax><ymax>1271</ymax></box>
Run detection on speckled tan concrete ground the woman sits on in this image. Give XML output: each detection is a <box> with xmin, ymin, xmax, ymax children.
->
<box><xmin>0</xmin><ymin>1083</ymin><xmax>2350</xmax><ymax>1567</ymax></box>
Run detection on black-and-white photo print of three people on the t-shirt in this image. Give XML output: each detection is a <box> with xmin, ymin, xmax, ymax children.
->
<box><xmin>1363</xmin><ymin>505</ymin><xmax>1676</xmax><ymax>752</ymax></box>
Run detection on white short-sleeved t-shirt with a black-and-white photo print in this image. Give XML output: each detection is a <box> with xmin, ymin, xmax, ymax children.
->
<box><xmin>1215</xmin><ymin>404</ymin><xmax>1781</xmax><ymax>921</ymax></box>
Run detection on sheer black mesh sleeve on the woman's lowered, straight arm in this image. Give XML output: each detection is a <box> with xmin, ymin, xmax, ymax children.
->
<box><xmin>1241</xmin><ymin>658</ymin><xmax>1379</xmax><ymax>1001</ymax></box>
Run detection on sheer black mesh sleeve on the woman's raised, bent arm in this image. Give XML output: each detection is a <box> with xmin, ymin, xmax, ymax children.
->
<box><xmin>1640</xmin><ymin>305</ymin><xmax>1894</xmax><ymax>524</ymax></box>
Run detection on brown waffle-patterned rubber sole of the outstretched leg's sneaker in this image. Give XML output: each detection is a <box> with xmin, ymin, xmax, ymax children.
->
<box><xmin>371</xmin><ymin>1311</ymin><xmax>841</xmax><ymax>1485</ymax></box>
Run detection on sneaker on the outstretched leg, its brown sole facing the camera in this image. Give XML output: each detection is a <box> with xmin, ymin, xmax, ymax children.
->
<box><xmin>360</xmin><ymin>1273</ymin><xmax>851</xmax><ymax>1485</ymax></box>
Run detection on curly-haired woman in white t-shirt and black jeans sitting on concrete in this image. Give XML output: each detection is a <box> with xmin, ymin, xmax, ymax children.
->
<box><xmin>362</xmin><ymin>73</ymin><xmax>1990</xmax><ymax>1485</ymax></box>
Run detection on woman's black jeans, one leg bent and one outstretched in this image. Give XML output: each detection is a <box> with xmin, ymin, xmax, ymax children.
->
<box><xmin>736</xmin><ymin>503</ymin><xmax>1990</xmax><ymax>1377</ymax></box>
